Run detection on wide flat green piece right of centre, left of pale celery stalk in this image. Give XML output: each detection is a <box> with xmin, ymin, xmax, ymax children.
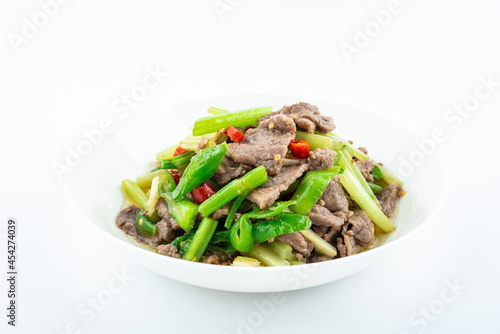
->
<box><xmin>290</xmin><ymin>167</ymin><xmax>340</xmax><ymax>215</ymax></box>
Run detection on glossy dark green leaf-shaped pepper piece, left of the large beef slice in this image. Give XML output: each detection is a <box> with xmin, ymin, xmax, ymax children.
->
<box><xmin>172</xmin><ymin>144</ymin><xmax>227</xmax><ymax>200</ymax></box>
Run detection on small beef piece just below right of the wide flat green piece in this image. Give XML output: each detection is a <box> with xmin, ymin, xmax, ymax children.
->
<box><xmin>309</xmin><ymin>209</ymin><xmax>352</xmax><ymax>244</ymax></box>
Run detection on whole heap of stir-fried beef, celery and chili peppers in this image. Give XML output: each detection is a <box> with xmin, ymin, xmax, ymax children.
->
<box><xmin>116</xmin><ymin>102</ymin><xmax>405</xmax><ymax>267</ymax></box>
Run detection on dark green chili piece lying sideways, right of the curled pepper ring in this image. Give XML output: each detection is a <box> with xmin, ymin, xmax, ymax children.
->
<box><xmin>252</xmin><ymin>212</ymin><xmax>311</xmax><ymax>244</ymax></box>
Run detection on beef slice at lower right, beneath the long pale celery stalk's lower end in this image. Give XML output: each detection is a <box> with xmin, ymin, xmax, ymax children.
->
<box><xmin>337</xmin><ymin>210</ymin><xmax>375</xmax><ymax>257</ymax></box>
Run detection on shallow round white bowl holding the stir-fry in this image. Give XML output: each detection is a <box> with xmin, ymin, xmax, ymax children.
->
<box><xmin>66</xmin><ymin>95</ymin><xmax>448</xmax><ymax>292</ymax></box>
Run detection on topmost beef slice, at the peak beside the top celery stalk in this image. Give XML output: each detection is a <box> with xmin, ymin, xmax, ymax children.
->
<box><xmin>259</xmin><ymin>102</ymin><xmax>335</xmax><ymax>133</ymax></box>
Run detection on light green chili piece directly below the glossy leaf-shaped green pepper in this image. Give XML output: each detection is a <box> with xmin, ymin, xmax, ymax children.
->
<box><xmin>159</xmin><ymin>172</ymin><xmax>198</xmax><ymax>232</ymax></box>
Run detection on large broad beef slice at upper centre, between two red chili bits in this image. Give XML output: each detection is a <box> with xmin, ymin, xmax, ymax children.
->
<box><xmin>227</xmin><ymin>115</ymin><xmax>296</xmax><ymax>175</ymax></box>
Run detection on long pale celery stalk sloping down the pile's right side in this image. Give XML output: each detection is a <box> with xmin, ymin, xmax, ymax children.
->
<box><xmin>340</xmin><ymin>170</ymin><xmax>394</xmax><ymax>233</ymax></box>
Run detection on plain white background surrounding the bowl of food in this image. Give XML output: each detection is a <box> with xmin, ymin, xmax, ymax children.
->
<box><xmin>0</xmin><ymin>0</ymin><xmax>500</xmax><ymax>333</ymax></box>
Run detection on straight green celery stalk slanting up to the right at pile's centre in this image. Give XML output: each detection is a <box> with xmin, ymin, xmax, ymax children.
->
<box><xmin>199</xmin><ymin>166</ymin><xmax>267</xmax><ymax>217</ymax></box>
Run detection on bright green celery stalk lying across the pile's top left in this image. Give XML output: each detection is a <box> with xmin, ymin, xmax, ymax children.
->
<box><xmin>193</xmin><ymin>106</ymin><xmax>273</xmax><ymax>136</ymax></box>
